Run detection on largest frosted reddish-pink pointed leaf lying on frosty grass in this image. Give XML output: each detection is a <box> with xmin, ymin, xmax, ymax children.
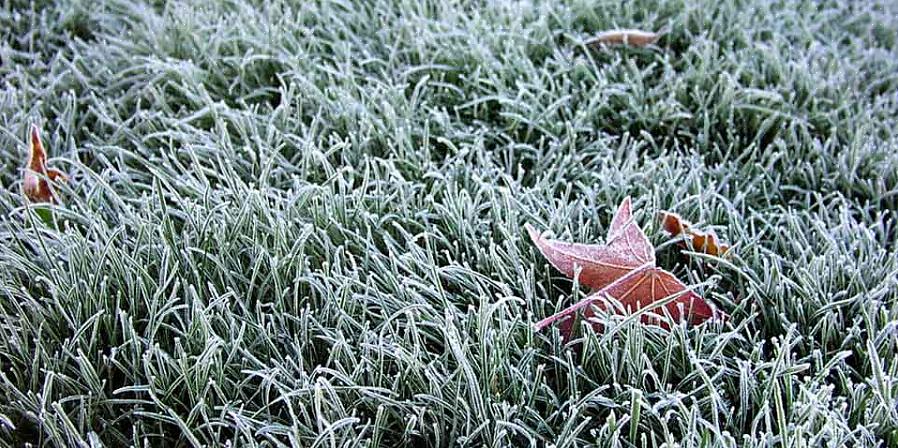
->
<box><xmin>526</xmin><ymin>197</ymin><xmax>723</xmax><ymax>339</ymax></box>
